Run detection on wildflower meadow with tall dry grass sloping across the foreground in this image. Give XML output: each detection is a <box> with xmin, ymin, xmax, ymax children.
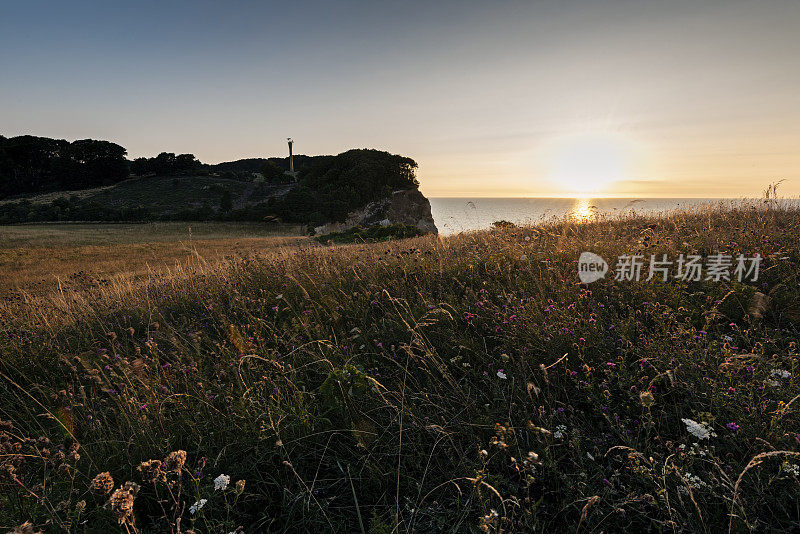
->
<box><xmin>0</xmin><ymin>204</ymin><xmax>800</xmax><ymax>534</ymax></box>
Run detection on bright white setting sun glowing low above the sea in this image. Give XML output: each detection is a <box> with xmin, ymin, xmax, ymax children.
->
<box><xmin>547</xmin><ymin>132</ymin><xmax>633</xmax><ymax>195</ymax></box>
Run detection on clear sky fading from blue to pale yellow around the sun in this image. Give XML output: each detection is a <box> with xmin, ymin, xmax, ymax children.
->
<box><xmin>0</xmin><ymin>0</ymin><xmax>800</xmax><ymax>197</ymax></box>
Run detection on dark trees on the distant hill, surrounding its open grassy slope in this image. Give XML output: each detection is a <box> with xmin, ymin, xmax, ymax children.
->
<box><xmin>0</xmin><ymin>136</ymin><xmax>418</xmax><ymax>226</ymax></box>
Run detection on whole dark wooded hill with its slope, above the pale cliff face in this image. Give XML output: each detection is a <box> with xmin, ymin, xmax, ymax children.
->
<box><xmin>0</xmin><ymin>136</ymin><xmax>417</xmax><ymax>226</ymax></box>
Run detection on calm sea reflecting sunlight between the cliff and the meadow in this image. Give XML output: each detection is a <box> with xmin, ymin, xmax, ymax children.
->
<box><xmin>430</xmin><ymin>198</ymin><xmax>758</xmax><ymax>234</ymax></box>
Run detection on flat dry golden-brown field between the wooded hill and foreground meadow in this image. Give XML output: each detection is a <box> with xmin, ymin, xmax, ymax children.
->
<box><xmin>0</xmin><ymin>222</ymin><xmax>305</xmax><ymax>300</ymax></box>
